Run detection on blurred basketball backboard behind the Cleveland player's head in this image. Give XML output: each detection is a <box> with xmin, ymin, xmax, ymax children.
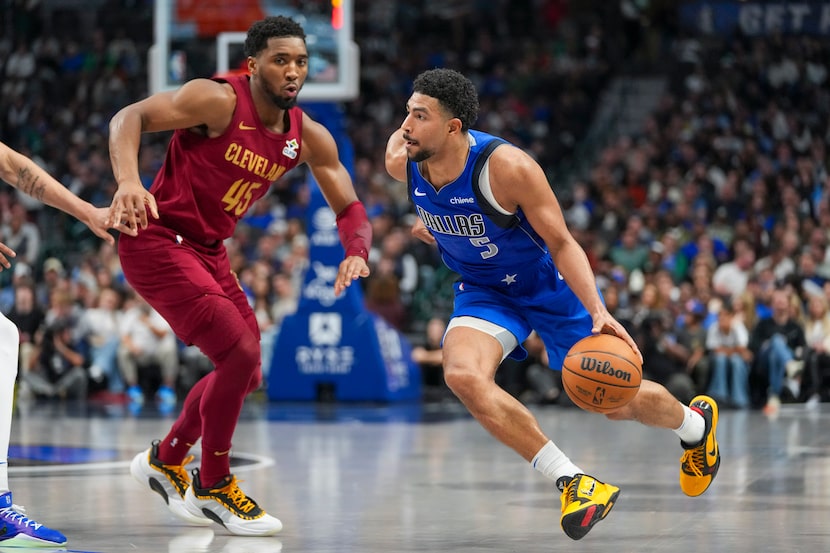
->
<box><xmin>148</xmin><ymin>0</ymin><xmax>360</xmax><ymax>101</ymax></box>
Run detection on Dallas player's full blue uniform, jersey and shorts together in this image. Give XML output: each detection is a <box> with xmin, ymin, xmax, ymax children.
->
<box><xmin>406</xmin><ymin>130</ymin><xmax>592</xmax><ymax>369</ymax></box>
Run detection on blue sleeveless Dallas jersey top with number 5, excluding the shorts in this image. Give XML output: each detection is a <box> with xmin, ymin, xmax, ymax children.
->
<box><xmin>407</xmin><ymin>130</ymin><xmax>559</xmax><ymax>292</ymax></box>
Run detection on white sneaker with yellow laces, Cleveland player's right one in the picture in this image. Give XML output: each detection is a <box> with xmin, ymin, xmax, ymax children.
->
<box><xmin>184</xmin><ymin>469</ymin><xmax>282</xmax><ymax>536</ymax></box>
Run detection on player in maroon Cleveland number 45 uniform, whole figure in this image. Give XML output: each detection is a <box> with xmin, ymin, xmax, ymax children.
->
<box><xmin>110</xmin><ymin>16</ymin><xmax>371</xmax><ymax>536</ymax></box>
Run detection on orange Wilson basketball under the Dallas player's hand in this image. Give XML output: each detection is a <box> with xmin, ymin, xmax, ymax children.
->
<box><xmin>562</xmin><ymin>334</ymin><xmax>643</xmax><ymax>413</ymax></box>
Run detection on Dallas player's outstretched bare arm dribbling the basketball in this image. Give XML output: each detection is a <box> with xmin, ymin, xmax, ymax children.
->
<box><xmin>490</xmin><ymin>146</ymin><xmax>642</xmax><ymax>360</ymax></box>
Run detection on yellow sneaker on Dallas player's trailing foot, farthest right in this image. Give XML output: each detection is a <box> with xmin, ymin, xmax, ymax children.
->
<box><xmin>680</xmin><ymin>396</ymin><xmax>720</xmax><ymax>497</ymax></box>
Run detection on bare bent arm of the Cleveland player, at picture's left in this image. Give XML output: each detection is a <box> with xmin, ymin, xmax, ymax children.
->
<box><xmin>109</xmin><ymin>79</ymin><xmax>236</xmax><ymax>231</ymax></box>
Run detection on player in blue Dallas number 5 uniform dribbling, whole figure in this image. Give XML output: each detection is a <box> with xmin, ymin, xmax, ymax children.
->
<box><xmin>386</xmin><ymin>69</ymin><xmax>720</xmax><ymax>540</ymax></box>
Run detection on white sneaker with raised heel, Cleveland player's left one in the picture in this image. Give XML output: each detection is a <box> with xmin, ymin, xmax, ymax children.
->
<box><xmin>130</xmin><ymin>440</ymin><xmax>211</xmax><ymax>526</ymax></box>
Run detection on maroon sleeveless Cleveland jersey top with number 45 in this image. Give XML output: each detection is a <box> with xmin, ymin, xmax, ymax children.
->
<box><xmin>150</xmin><ymin>75</ymin><xmax>303</xmax><ymax>244</ymax></box>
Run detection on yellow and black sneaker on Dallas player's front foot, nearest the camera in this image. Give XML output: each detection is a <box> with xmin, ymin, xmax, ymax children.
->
<box><xmin>556</xmin><ymin>474</ymin><xmax>620</xmax><ymax>540</ymax></box>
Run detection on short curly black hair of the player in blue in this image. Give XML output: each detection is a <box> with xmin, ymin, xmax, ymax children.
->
<box><xmin>412</xmin><ymin>69</ymin><xmax>478</xmax><ymax>132</ymax></box>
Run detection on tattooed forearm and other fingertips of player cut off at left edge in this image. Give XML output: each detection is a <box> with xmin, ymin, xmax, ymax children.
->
<box><xmin>0</xmin><ymin>142</ymin><xmax>130</xmax><ymax>268</ymax></box>
